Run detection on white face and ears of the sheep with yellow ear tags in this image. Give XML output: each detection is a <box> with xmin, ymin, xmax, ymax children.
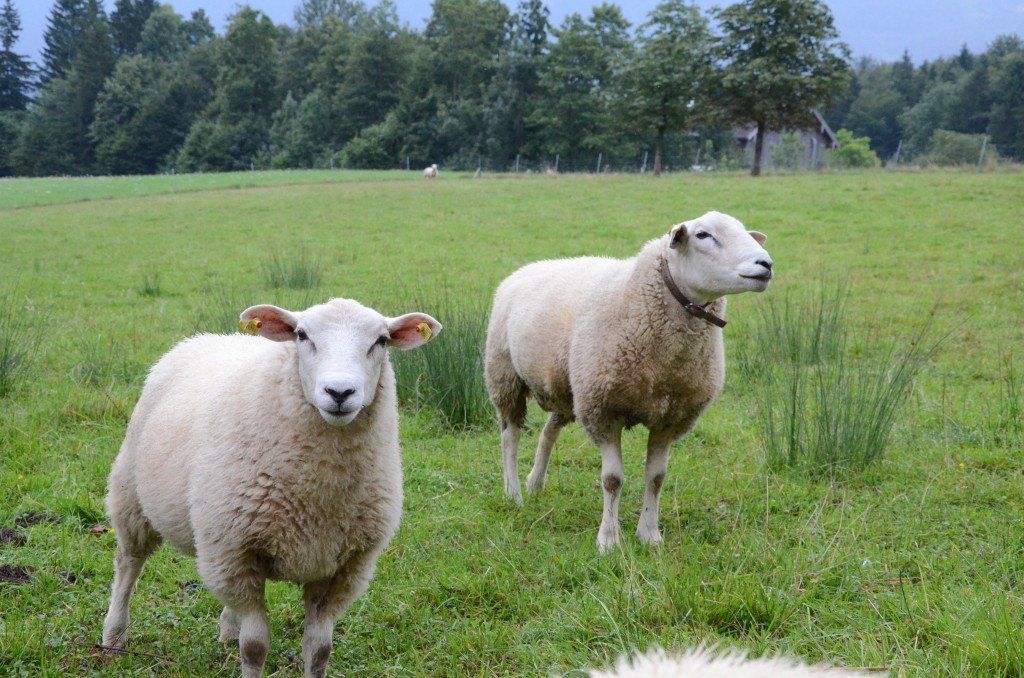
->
<box><xmin>242</xmin><ymin>299</ymin><xmax>441</xmax><ymax>426</ymax></box>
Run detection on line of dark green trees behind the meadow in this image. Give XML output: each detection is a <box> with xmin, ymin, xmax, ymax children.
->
<box><xmin>0</xmin><ymin>0</ymin><xmax>1024</xmax><ymax>175</ymax></box>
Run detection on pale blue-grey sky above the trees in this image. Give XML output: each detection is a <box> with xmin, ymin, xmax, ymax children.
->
<box><xmin>14</xmin><ymin>0</ymin><xmax>1024</xmax><ymax>62</ymax></box>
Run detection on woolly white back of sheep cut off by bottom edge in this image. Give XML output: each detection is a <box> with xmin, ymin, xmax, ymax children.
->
<box><xmin>590</xmin><ymin>647</ymin><xmax>868</xmax><ymax>678</ymax></box>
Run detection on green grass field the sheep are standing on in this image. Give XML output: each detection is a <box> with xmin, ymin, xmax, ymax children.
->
<box><xmin>0</xmin><ymin>172</ymin><xmax>1024</xmax><ymax>676</ymax></box>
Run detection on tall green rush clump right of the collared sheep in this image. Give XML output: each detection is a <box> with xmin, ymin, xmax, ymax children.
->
<box><xmin>744</xmin><ymin>292</ymin><xmax>937</xmax><ymax>476</ymax></box>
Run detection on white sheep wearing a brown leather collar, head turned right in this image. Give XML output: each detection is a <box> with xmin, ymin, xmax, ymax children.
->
<box><xmin>484</xmin><ymin>212</ymin><xmax>772</xmax><ymax>552</ymax></box>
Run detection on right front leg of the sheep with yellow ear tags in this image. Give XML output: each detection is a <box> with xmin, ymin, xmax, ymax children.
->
<box><xmin>302</xmin><ymin>551</ymin><xmax>380</xmax><ymax>678</ymax></box>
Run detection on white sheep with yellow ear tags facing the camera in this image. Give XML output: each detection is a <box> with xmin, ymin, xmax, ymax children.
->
<box><xmin>103</xmin><ymin>299</ymin><xmax>441</xmax><ymax>676</ymax></box>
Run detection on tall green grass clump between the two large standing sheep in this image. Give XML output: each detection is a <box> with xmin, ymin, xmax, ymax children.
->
<box><xmin>391</xmin><ymin>295</ymin><xmax>494</xmax><ymax>430</ymax></box>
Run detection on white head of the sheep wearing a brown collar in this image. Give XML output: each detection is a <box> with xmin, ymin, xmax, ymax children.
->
<box><xmin>668</xmin><ymin>212</ymin><xmax>772</xmax><ymax>303</ymax></box>
